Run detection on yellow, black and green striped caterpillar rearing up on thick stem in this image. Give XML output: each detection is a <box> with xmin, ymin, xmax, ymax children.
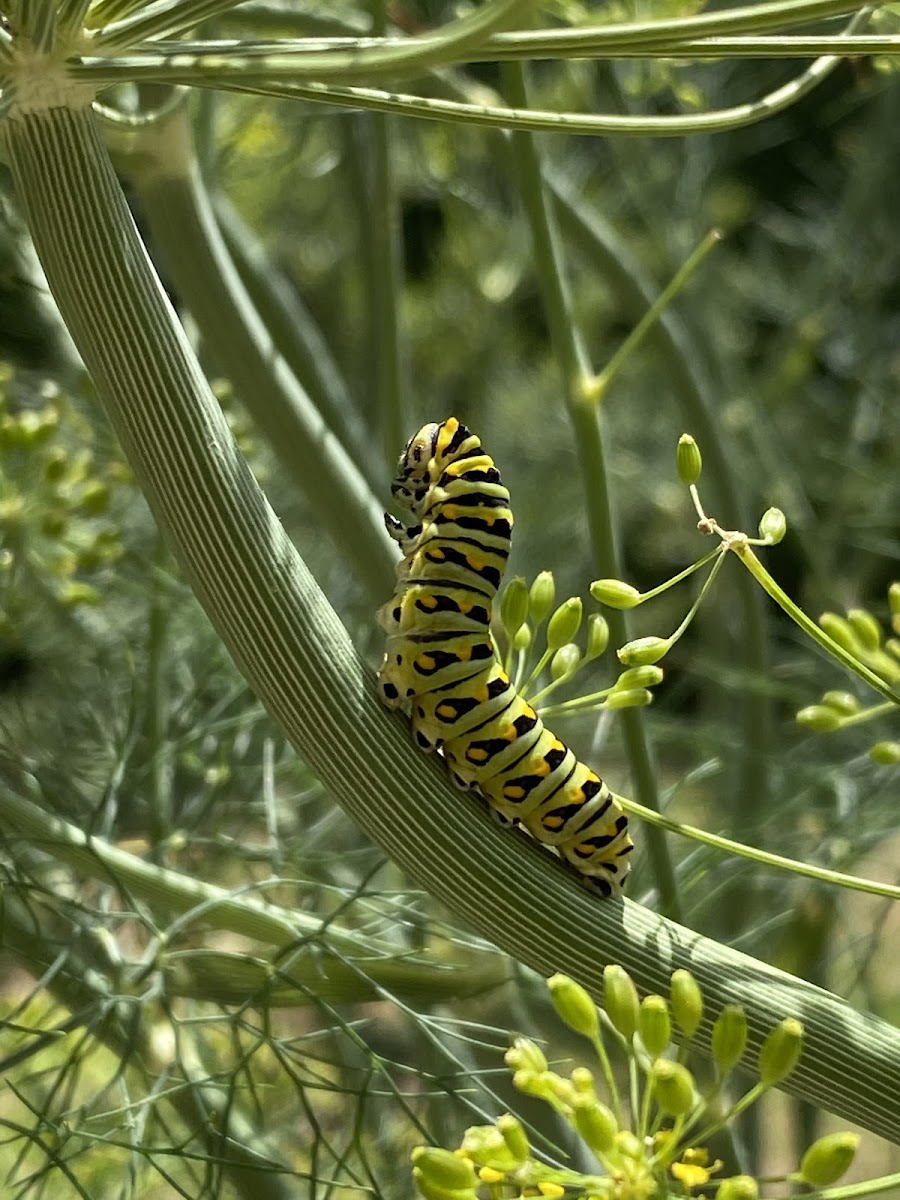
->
<box><xmin>378</xmin><ymin>416</ymin><xmax>632</xmax><ymax>896</ymax></box>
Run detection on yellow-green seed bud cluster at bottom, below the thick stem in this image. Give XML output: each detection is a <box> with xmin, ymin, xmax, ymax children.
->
<box><xmin>413</xmin><ymin>965</ymin><xmax>858</xmax><ymax>1200</ymax></box>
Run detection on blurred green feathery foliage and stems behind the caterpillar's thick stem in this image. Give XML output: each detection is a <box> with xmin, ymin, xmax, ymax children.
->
<box><xmin>0</xmin><ymin>0</ymin><xmax>900</xmax><ymax>1200</ymax></box>
